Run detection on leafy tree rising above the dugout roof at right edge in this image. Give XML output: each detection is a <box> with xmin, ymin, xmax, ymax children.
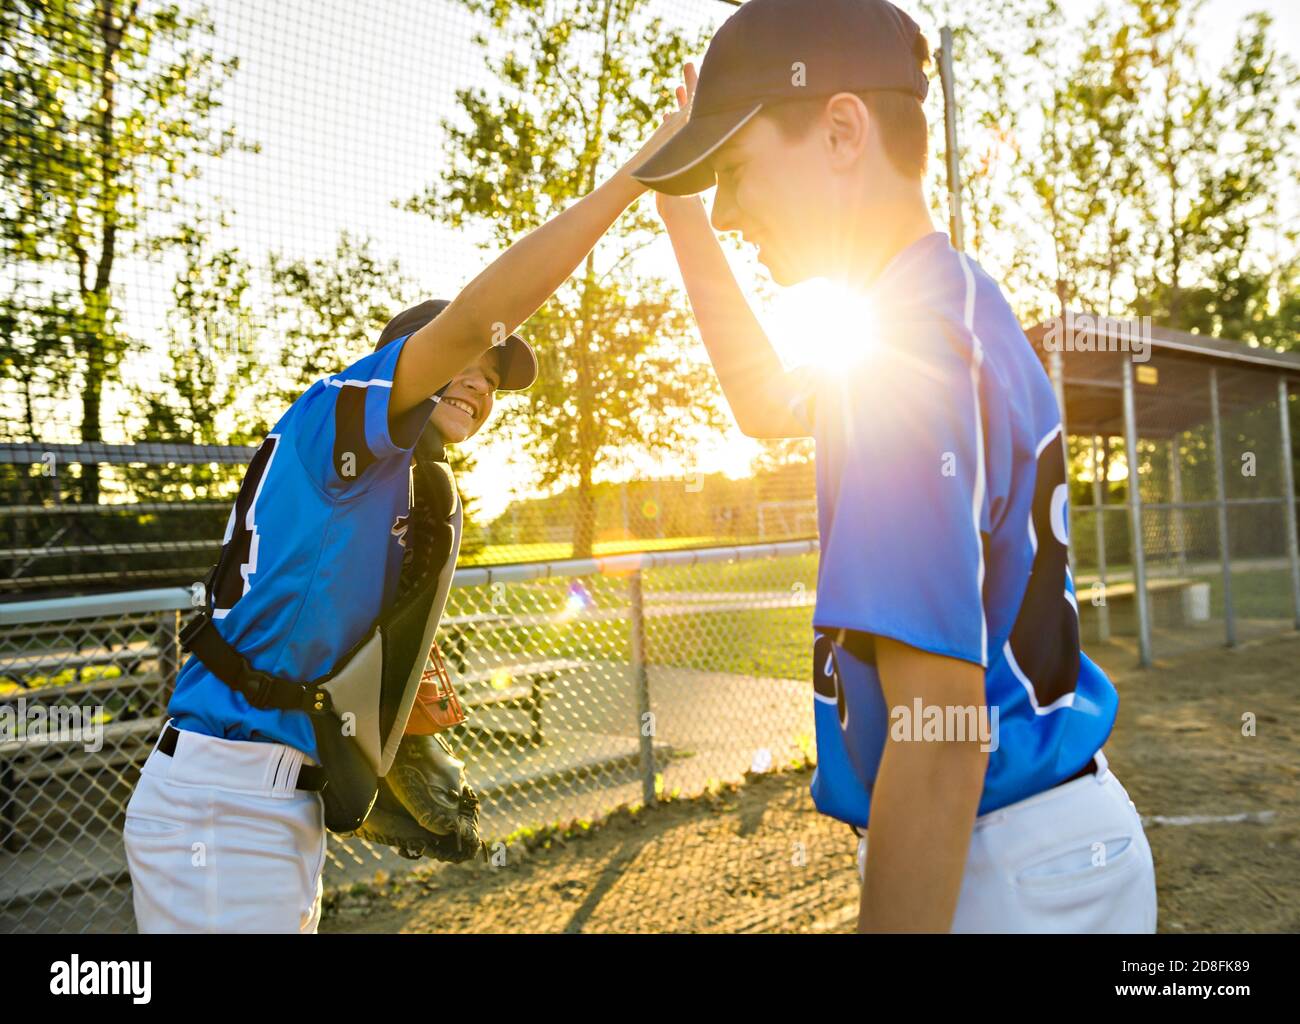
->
<box><xmin>1024</xmin><ymin>0</ymin><xmax>1297</xmax><ymax>335</ymax></box>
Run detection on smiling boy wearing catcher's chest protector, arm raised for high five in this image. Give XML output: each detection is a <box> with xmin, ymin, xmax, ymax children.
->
<box><xmin>124</xmin><ymin>98</ymin><xmax>685</xmax><ymax>932</ymax></box>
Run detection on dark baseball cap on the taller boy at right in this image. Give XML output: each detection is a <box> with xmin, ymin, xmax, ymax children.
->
<box><xmin>632</xmin><ymin>0</ymin><xmax>930</xmax><ymax>195</ymax></box>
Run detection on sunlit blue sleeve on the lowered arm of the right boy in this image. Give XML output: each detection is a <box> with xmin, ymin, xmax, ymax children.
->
<box><xmin>818</xmin><ymin>326</ymin><xmax>988</xmax><ymax>667</ymax></box>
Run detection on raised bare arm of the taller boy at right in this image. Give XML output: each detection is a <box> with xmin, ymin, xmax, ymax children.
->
<box><xmin>664</xmin><ymin>196</ymin><xmax>813</xmax><ymax>438</ymax></box>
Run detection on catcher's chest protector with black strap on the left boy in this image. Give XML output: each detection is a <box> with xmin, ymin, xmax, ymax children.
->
<box><xmin>181</xmin><ymin>446</ymin><xmax>463</xmax><ymax>832</ymax></box>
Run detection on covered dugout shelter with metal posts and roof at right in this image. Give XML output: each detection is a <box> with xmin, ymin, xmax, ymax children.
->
<box><xmin>1027</xmin><ymin>313</ymin><xmax>1300</xmax><ymax>665</ymax></box>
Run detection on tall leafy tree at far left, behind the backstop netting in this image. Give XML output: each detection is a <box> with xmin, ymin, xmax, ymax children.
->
<box><xmin>0</xmin><ymin>0</ymin><xmax>256</xmax><ymax>503</ymax></box>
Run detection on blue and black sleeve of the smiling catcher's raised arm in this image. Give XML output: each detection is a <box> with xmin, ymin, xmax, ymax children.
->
<box><xmin>278</xmin><ymin>335</ymin><xmax>436</xmax><ymax>496</ymax></box>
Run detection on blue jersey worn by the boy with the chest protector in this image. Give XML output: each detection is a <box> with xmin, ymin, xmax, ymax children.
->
<box><xmin>168</xmin><ymin>335</ymin><xmax>436</xmax><ymax>760</ymax></box>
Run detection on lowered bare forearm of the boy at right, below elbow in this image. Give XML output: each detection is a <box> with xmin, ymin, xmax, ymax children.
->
<box><xmin>858</xmin><ymin>741</ymin><xmax>988</xmax><ymax>932</ymax></box>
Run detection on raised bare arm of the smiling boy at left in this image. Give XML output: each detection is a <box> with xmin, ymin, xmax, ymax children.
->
<box><xmin>389</xmin><ymin>110</ymin><xmax>686</xmax><ymax>417</ymax></box>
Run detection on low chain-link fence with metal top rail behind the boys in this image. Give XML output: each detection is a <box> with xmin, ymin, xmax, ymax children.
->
<box><xmin>0</xmin><ymin>541</ymin><xmax>818</xmax><ymax>930</ymax></box>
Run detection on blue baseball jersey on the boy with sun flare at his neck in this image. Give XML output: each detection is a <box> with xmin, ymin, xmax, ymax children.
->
<box><xmin>792</xmin><ymin>233</ymin><xmax>1118</xmax><ymax>828</ymax></box>
